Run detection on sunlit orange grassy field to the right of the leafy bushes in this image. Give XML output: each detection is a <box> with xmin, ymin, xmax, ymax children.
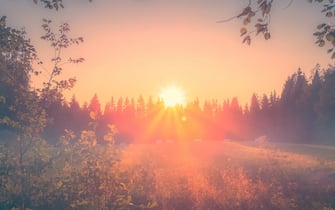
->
<box><xmin>120</xmin><ymin>142</ymin><xmax>335</xmax><ymax>209</ymax></box>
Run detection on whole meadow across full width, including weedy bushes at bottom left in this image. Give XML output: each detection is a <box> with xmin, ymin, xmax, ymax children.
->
<box><xmin>0</xmin><ymin>140</ymin><xmax>335</xmax><ymax>210</ymax></box>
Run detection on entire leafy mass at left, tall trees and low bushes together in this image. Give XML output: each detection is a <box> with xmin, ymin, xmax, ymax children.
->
<box><xmin>0</xmin><ymin>18</ymin><xmax>152</xmax><ymax>210</ymax></box>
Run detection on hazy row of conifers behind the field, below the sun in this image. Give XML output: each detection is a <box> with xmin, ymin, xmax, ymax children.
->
<box><xmin>15</xmin><ymin>66</ymin><xmax>335</xmax><ymax>143</ymax></box>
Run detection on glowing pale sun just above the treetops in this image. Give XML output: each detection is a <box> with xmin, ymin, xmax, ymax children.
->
<box><xmin>159</xmin><ymin>86</ymin><xmax>186</xmax><ymax>107</ymax></box>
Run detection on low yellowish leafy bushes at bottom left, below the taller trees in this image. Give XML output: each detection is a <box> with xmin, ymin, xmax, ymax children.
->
<box><xmin>0</xmin><ymin>113</ymin><xmax>150</xmax><ymax>209</ymax></box>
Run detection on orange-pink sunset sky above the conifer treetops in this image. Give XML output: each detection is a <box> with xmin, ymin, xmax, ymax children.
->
<box><xmin>0</xmin><ymin>0</ymin><xmax>332</xmax><ymax>105</ymax></box>
